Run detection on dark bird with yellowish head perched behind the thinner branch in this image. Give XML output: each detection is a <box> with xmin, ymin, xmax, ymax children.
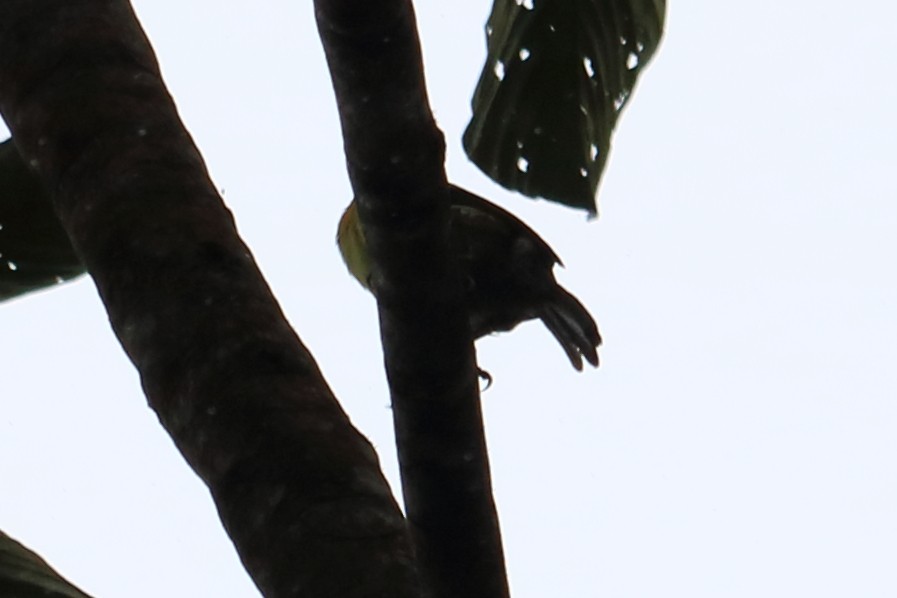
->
<box><xmin>336</xmin><ymin>185</ymin><xmax>601</xmax><ymax>371</ymax></box>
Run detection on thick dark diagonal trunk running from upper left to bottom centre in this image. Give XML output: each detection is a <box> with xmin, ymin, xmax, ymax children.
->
<box><xmin>0</xmin><ymin>0</ymin><xmax>420</xmax><ymax>597</ymax></box>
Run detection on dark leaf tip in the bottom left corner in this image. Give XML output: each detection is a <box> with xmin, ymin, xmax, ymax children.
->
<box><xmin>0</xmin><ymin>532</ymin><xmax>90</xmax><ymax>598</ymax></box>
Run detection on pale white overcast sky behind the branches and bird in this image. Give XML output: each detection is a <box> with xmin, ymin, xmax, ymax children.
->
<box><xmin>0</xmin><ymin>0</ymin><xmax>897</xmax><ymax>598</ymax></box>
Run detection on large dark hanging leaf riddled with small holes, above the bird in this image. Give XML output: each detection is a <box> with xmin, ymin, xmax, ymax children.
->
<box><xmin>464</xmin><ymin>0</ymin><xmax>666</xmax><ymax>214</ymax></box>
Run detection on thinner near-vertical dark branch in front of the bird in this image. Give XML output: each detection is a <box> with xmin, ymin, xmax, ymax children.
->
<box><xmin>315</xmin><ymin>0</ymin><xmax>508</xmax><ymax>598</ymax></box>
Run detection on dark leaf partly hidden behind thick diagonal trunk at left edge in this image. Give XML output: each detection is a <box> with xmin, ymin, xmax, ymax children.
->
<box><xmin>0</xmin><ymin>139</ymin><xmax>84</xmax><ymax>301</ymax></box>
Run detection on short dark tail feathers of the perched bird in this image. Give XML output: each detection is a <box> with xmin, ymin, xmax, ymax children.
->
<box><xmin>540</xmin><ymin>286</ymin><xmax>601</xmax><ymax>371</ymax></box>
